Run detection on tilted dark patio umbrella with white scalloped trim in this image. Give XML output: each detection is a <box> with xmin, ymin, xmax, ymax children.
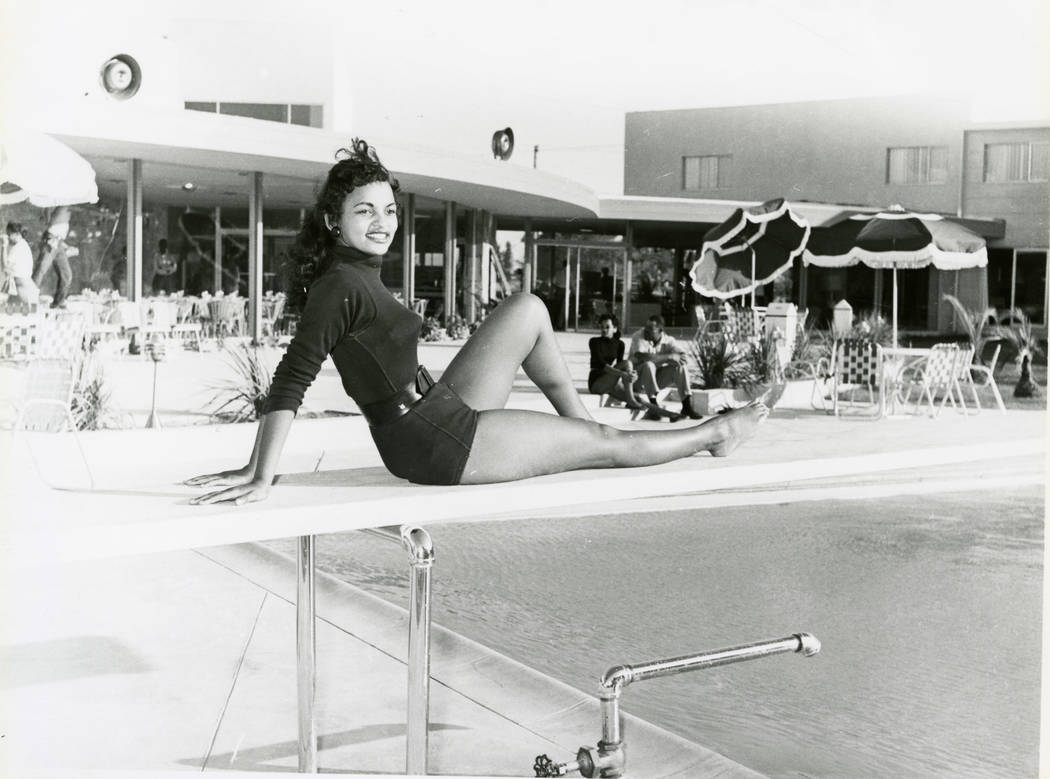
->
<box><xmin>689</xmin><ymin>198</ymin><xmax>810</xmax><ymax>306</ymax></box>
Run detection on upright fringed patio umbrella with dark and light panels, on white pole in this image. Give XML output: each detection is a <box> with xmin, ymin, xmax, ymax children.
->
<box><xmin>802</xmin><ymin>205</ymin><xmax>988</xmax><ymax>346</ymax></box>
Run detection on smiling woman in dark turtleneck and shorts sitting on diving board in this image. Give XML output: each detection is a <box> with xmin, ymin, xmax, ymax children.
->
<box><xmin>187</xmin><ymin>139</ymin><xmax>769</xmax><ymax>504</ymax></box>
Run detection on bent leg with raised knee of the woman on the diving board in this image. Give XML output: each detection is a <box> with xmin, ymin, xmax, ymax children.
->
<box><xmin>441</xmin><ymin>294</ymin><xmax>591</xmax><ymax>420</ymax></box>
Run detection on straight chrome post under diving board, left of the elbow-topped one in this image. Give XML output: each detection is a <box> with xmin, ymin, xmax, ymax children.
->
<box><xmin>295</xmin><ymin>535</ymin><xmax>317</xmax><ymax>774</ymax></box>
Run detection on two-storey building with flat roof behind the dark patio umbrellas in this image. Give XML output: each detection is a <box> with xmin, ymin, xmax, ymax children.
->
<box><xmin>624</xmin><ymin>96</ymin><xmax>1050</xmax><ymax>332</ymax></box>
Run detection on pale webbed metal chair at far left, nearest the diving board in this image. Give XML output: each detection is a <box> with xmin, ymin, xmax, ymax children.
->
<box><xmin>14</xmin><ymin>312</ymin><xmax>95</xmax><ymax>489</ymax></box>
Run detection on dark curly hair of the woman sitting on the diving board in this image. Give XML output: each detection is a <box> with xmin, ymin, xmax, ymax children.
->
<box><xmin>288</xmin><ymin>138</ymin><xmax>400</xmax><ymax>309</ymax></box>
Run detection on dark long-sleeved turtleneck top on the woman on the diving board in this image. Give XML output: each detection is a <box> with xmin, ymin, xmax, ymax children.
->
<box><xmin>265</xmin><ymin>246</ymin><xmax>422</xmax><ymax>414</ymax></box>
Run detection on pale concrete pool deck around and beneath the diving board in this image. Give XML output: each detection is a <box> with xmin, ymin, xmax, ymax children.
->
<box><xmin>0</xmin><ymin>336</ymin><xmax>1046</xmax><ymax>777</ymax></box>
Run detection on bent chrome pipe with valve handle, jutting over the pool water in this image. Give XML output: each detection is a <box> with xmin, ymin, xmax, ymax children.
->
<box><xmin>532</xmin><ymin>633</ymin><xmax>820</xmax><ymax>779</ymax></box>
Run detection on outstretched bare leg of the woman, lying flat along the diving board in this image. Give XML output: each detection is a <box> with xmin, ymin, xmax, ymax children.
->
<box><xmin>462</xmin><ymin>403</ymin><xmax>769</xmax><ymax>484</ymax></box>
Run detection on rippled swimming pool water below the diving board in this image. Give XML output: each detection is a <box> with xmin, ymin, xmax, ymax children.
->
<box><xmin>270</xmin><ymin>486</ymin><xmax>1044</xmax><ymax>779</ymax></box>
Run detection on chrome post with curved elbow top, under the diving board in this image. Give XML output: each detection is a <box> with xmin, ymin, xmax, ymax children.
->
<box><xmin>401</xmin><ymin>525</ymin><xmax>434</xmax><ymax>775</ymax></box>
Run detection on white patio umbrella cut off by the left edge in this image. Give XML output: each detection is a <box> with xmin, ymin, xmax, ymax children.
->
<box><xmin>0</xmin><ymin>130</ymin><xmax>99</xmax><ymax>208</ymax></box>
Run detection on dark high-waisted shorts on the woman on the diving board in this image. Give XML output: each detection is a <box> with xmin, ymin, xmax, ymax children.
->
<box><xmin>369</xmin><ymin>381</ymin><xmax>478</xmax><ymax>484</ymax></box>
